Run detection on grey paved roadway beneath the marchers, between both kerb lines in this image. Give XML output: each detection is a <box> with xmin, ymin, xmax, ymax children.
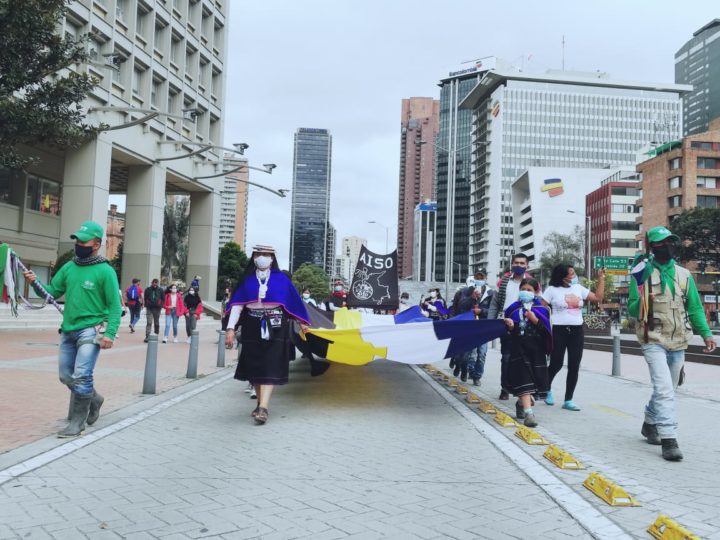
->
<box><xmin>0</xmin><ymin>362</ymin><xmax>590</xmax><ymax>539</ymax></box>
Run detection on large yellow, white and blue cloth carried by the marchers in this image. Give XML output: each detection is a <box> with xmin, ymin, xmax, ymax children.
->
<box><xmin>305</xmin><ymin>306</ymin><xmax>507</xmax><ymax>366</ymax></box>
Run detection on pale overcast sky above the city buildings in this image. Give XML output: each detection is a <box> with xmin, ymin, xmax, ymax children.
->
<box><xmin>225</xmin><ymin>0</ymin><xmax>720</xmax><ymax>266</ymax></box>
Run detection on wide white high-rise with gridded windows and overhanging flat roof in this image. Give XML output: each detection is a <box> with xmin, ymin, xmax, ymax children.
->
<box><xmin>458</xmin><ymin>70</ymin><xmax>691</xmax><ymax>278</ymax></box>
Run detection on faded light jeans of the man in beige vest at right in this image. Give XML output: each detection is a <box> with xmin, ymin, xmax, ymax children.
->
<box><xmin>642</xmin><ymin>343</ymin><xmax>685</xmax><ymax>439</ymax></box>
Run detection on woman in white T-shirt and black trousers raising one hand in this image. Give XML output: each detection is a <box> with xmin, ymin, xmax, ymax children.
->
<box><xmin>542</xmin><ymin>264</ymin><xmax>605</xmax><ymax>411</ymax></box>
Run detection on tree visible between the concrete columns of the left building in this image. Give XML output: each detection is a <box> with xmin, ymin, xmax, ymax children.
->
<box><xmin>161</xmin><ymin>197</ymin><xmax>190</xmax><ymax>281</ymax></box>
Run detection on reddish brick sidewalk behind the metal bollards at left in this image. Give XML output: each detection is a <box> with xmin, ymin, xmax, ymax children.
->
<box><xmin>0</xmin><ymin>320</ymin><xmax>228</xmax><ymax>454</ymax></box>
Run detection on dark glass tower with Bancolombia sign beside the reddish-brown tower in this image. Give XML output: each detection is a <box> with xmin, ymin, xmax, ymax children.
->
<box><xmin>435</xmin><ymin>56</ymin><xmax>509</xmax><ymax>281</ymax></box>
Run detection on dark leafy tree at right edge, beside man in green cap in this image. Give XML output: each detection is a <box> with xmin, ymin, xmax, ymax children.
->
<box><xmin>670</xmin><ymin>208</ymin><xmax>720</xmax><ymax>270</ymax></box>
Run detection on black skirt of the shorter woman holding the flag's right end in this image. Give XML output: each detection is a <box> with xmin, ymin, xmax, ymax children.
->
<box><xmin>507</xmin><ymin>335</ymin><xmax>549</xmax><ymax>399</ymax></box>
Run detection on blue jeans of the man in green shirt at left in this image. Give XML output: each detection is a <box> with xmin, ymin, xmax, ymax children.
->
<box><xmin>58</xmin><ymin>326</ymin><xmax>100</xmax><ymax>396</ymax></box>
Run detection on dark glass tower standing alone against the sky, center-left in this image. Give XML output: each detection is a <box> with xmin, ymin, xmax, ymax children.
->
<box><xmin>290</xmin><ymin>128</ymin><xmax>332</xmax><ymax>272</ymax></box>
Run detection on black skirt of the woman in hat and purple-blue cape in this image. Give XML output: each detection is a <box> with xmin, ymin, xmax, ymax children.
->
<box><xmin>235</xmin><ymin>308</ymin><xmax>294</xmax><ymax>385</ymax></box>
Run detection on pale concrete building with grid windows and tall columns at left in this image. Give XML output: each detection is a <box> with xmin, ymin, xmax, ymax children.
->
<box><xmin>0</xmin><ymin>0</ymin><xmax>227</xmax><ymax>297</ymax></box>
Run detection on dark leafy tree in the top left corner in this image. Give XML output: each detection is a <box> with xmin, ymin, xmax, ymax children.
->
<box><xmin>0</xmin><ymin>0</ymin><xmax>97</xmax><ymax>169</ymax></box>
